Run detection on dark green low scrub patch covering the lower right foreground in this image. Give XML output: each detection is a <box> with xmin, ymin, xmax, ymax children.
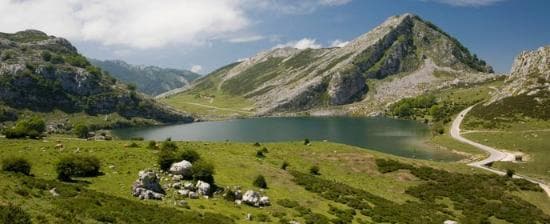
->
<box><xmin>291</xmin><ymin>159</ymin><xmax>550</xmax><ymax>223</ymax></box>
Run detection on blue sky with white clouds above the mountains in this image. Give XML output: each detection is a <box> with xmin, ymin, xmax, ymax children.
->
<box><xmin>0</xmin><ymin>0</ymin><xmax>550</xmax><ymax>74</ymax></box>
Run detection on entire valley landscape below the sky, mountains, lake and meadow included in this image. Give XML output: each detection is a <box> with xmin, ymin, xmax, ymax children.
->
<box><xmin>0</xmin><ymin>7</ymin><xmax>550</xmax><ymax>224</ymax></box>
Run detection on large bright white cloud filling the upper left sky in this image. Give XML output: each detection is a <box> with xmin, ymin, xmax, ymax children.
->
<box><xmin>0</xmin><ymin>0</ymin><xmax>250</xmax><ymax>49</ymax></box>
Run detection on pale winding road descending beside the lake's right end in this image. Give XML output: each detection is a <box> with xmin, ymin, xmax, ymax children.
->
<box><xmin>450</xmin><ymin>106</ymin><xmax>550</xmax><ymax>197</ymax></box>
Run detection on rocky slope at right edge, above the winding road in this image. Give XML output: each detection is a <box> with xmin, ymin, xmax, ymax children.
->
<box><xmin>471</xmin><ymin>45</ymin><xmax>550</xmax><ymax>127</ymax></box>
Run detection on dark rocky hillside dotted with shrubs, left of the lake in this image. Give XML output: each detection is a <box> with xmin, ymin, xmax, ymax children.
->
<box><xmin>0</xmin><ymin>30</ymin><xmax>192</xmax><ymax>126</ymax></box>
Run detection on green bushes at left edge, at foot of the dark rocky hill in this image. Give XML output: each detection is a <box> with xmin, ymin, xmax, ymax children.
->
<box><xmin>2</xmin><ymin>116</ymin><xmax>46</xmax><ymax>138</ymax></box>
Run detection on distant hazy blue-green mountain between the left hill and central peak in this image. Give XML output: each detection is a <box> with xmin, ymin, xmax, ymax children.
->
<box><xmin>90</xmin><ymin>59</ymin><xmax>200</xmax><ymax>96</ymax></box>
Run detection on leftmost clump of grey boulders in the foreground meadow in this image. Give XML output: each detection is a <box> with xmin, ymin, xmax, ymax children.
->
<box><xmin>132</xmin><ymin>170</ymin><xmax>164</xmax><ymax>200</ymax></box>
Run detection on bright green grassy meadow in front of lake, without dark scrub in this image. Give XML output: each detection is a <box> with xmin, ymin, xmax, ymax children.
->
<box><xmin>0</xmin><ymin>137</ymin><xmax>550</xmax><ymax>223</ymax></box>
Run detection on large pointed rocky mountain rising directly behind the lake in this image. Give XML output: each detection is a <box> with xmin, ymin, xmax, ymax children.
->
<box><xmin>167</xmin><ymin>14</ymin><xmax>498</xmax><ymax>115</ymax></box>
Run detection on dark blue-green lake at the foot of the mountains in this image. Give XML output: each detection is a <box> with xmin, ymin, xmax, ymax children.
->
<box><xmin>113</xmin><ymin>117</ymin><xmax>461</xmax><ymax>161</ymax></box>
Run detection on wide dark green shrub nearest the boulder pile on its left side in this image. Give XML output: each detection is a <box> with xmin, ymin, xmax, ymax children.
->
<box><xmin>56</xmin><ymin>155</ymin><xmax>101</xmax><ymax>181</ymax></box>
